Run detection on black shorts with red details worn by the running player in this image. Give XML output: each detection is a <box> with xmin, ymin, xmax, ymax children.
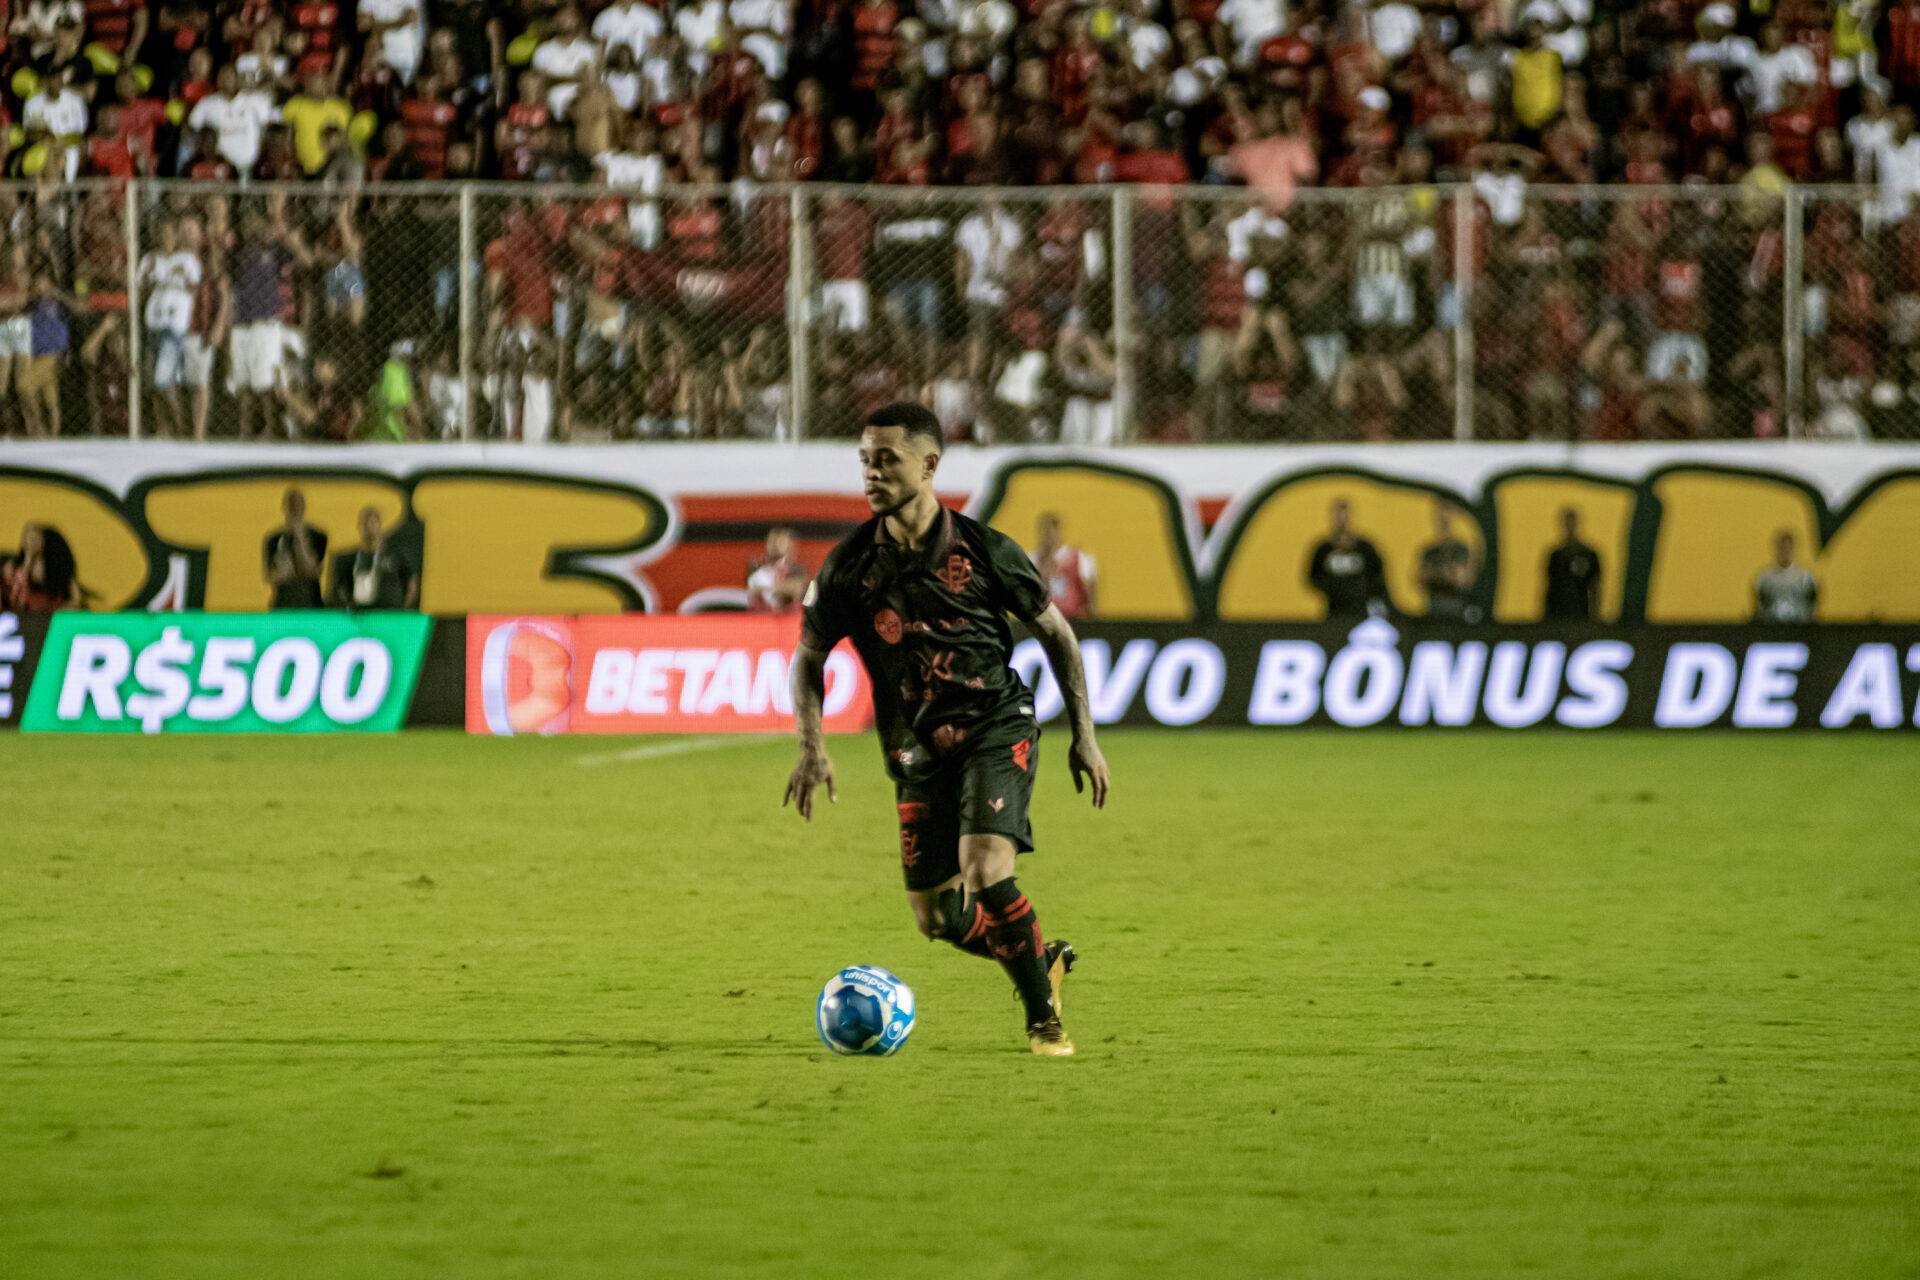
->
<box><xmin>895</xmin><ymin>723</ymin><xmax>1041</xmax><ymax>890</ymax></box>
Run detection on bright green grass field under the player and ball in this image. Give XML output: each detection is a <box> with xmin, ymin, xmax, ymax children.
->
<box><xmin>0</xmin><ymin>733</ymin><xmax>1920</xmax><ymax>1280</ymax></box>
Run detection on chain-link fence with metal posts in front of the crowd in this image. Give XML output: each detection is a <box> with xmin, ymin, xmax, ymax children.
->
<box><xmin>0</xmin><ymin>169</ymin><xmax>1920</xmax><ymax>445</ymax></box>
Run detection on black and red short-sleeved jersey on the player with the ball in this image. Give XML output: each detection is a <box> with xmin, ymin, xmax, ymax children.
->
<box><xmin>801</xmin><ymin>507</ymin><xmax>1048</xmax><ymax>781</ymax></box>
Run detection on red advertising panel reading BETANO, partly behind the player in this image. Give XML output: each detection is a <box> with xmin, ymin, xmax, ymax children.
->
<box><xmin>467</xmin><ymin>614</ymin><xmax>874</xmax><ymax>735</ymax></box>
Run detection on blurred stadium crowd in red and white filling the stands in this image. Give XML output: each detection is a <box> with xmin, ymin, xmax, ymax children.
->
<box><xmin>0</xmin><ymin>0</ymin><xmax>1920</xmax><ymax>443</ymax></box>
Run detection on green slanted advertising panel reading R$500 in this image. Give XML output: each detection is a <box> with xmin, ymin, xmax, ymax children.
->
<box><xmin>19</xmin><ymin>612</ymin><xmax>434</xmax><ymax>733</ymax></box>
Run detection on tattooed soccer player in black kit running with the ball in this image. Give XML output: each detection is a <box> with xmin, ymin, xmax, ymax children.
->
<box><xmin>781</xmin><ymin>403</ymin><xmax>1108</xmax><ymax>1057</ymax></box>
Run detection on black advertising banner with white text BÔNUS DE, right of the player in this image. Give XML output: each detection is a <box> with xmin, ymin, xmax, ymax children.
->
<box><xmin>1014</xmin><ymin>620</ymin><xmax>1920</xmax><ymax>729</ymax></box>
